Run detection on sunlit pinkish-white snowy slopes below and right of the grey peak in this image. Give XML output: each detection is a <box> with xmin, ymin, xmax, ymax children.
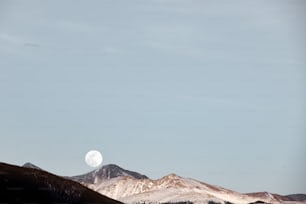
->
<box><xmin>83</xmin><ymin>174</ymin><xmax>279</xmax><ymax>204</ymax></box>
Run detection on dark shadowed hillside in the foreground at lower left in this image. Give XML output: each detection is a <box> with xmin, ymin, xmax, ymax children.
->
<box><xmin>0</xmin><ymin>163</ymin><xmax>120</xmax><ymax>204</ymax></box>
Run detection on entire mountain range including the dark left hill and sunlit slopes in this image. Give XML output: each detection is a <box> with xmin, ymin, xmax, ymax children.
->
<box><xmin>0</xmin><ymin>163</ymin><xmax>306</xmax><ymax>204</ymax></box>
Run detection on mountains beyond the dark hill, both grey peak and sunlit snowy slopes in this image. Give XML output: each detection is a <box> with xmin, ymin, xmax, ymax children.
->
<box><xmin>70</xmin><ymin>164</ymin><xmax>306</xmax><ymax>203</ymax></box>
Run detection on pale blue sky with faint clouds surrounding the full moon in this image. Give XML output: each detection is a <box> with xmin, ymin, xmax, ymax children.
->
<box><xmin>0</xmin><ymin>0</ymin><xmax>306</xmax><ymax>194</ymax></box>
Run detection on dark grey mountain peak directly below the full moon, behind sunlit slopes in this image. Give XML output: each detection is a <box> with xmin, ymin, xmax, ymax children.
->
<box><xmin>70</xmin><ymin>164</ymin><xmax>148</xmax><ymax>184</ymax></box>
